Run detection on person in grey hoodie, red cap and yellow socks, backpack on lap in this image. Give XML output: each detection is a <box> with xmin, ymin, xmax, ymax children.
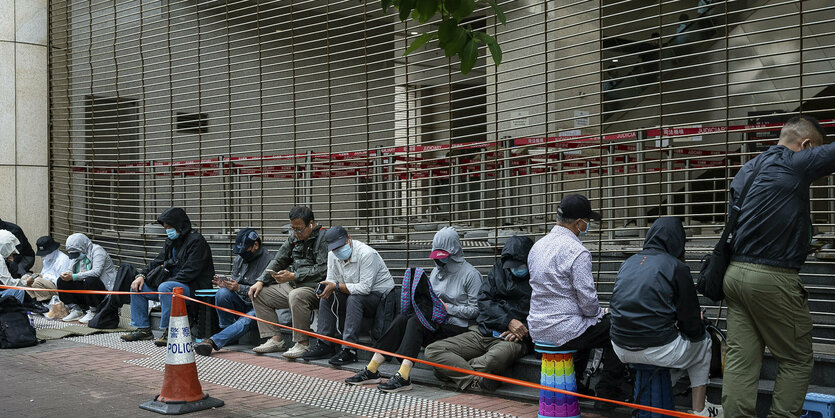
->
<box><xmin>345</xmin><ymin>227</ymin><xmax>482</xmax><ymax>392</ymax></box>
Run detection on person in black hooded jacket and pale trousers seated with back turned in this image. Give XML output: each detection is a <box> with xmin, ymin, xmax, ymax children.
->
<box><xmin>609</xmin><ymin>217</ymin><xmax>722</xmax><ymax>417</ymax></box>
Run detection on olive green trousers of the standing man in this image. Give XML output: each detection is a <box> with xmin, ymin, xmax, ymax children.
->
<box><xmin>722</xmin><ymin>262</ymin><xmax>814</xmax><ymax>418</ymax></box>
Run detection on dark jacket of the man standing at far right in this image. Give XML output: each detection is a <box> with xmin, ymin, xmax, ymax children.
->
<box><xmin>730</xmin><ymin>144</ymin><xmax>835</xmax><ymax>270</ymax></box>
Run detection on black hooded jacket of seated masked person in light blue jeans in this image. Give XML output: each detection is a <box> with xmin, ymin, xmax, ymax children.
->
<box><xmin>143</xmin><ymin>208</ymin><xmax>215</xmax><ymax>291</ymax></box>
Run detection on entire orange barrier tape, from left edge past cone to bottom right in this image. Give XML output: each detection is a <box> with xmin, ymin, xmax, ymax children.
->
<box><xmin>0</xmin><ymin>285</ymin><xmax>698</xmax><ymax>418</ymax></box>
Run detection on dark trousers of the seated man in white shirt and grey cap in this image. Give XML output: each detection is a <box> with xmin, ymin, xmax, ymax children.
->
<box><xmin>318</xmin><ymin>291</ymin><xmax>383</xmax><ymax>348</ymax></box>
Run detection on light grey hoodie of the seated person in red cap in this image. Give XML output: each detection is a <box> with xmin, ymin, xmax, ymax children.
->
<box><xmin>429</xmin><ymin>226</ymin><xmax>482</xmax><ymax>327</ymax></box>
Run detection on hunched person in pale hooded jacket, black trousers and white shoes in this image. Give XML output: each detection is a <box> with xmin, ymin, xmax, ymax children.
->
<box><xmin>58</xmin><ymin>233</ymin><xmax>116</xmax><ymax>324</ymax></box>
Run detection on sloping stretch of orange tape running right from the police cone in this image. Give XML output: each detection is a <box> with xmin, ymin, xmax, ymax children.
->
<box><xmin>174</xmin><ymin>295</ymin><xmax>698</xmax><ymax>418</ymax></box>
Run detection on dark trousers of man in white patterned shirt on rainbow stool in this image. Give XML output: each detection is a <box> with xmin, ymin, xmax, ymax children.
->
<box><xmin>560</xmin><ymin>314</ymin><xmax>626</xmax><ymax>397</ymax></box>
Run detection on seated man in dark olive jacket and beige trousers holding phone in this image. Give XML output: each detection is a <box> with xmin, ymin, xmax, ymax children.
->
<box><xmin>249</xmin><ymin>206</ymin><xmax>328</xmax><ymax>360</ymax></box>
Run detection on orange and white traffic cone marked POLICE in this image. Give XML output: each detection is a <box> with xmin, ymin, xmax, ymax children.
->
<box><xmin>139</xmin><ymin>287</ymin><xmax>223</xmax><ymax>415</ymax></box>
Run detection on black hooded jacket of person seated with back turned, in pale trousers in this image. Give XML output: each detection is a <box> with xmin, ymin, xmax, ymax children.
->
<box><xmin>609</xmin><ymin>217</ymin><xmax>707</xmax><ymax>350</ymax></box>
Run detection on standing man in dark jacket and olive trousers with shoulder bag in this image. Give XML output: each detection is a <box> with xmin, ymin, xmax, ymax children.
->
<box><xmin>722</xmin><ymin>116</ymin><xmax>835</xmax><ymax>417</ymax></box>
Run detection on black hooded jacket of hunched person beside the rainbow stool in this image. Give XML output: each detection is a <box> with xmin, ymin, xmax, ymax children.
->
<box><xmin>476</xmin><ymin>236</ymin><xmax>533</xmax><ymax>337</ymax></box>
